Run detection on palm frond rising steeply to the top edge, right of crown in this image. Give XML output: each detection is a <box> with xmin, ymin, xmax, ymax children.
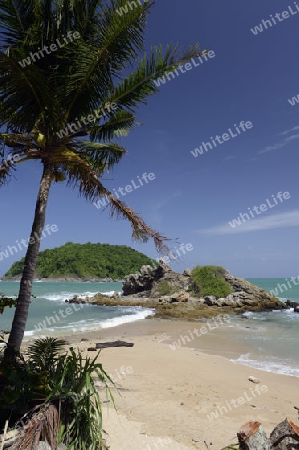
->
<box><xmin>63</xmin><ymin>0</ymin><xmax>154</xmax><ymax>119</ymax></box>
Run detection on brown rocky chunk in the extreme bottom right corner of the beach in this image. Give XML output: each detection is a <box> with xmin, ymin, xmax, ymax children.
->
<box><xmin>270</xmin><ymin>418</ymin><xmax>299</xmax><ymax>450</ymax></box>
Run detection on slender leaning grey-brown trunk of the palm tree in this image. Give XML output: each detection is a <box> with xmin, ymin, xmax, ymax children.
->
<box><xmin>8</xmin><ymin>165</ymin><xmax>52</xmax><ymax>351</ymax></box>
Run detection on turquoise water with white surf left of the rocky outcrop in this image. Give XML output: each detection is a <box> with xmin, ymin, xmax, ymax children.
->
<box><xmin>0</xmin><ymin>281</ymin><xmax>153</xmax><ymax>339</ymax></box>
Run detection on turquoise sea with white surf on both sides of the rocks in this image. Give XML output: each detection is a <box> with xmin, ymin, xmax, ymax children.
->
<box><xmin>0</xmin><ymin>278</ymin><xmax>299</xmax><ymax>377</ymax></box>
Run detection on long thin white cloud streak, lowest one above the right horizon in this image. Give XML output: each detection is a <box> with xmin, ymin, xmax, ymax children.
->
<box><xmin>196</xmin><ymin>209</ymin><xmax>299</xmax><ymax>236</ymax></box>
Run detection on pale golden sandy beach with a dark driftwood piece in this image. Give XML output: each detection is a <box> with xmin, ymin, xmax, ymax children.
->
<box><xmin>56</xmin><ymin>320</ymin><xmax>298</xmax><ymax>450</ymax></box>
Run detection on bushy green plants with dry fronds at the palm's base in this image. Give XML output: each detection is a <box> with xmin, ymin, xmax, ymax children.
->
<box><xmin>0</xmin><ymin>338</ymin><xmax>114</xmax><ymax>450</ymax></box>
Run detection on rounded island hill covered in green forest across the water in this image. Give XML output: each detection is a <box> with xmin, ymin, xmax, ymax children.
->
<box><xmin>5</xmin><ymin>242</ymin><xmax>153</xmax><ymax>279</ymax></box>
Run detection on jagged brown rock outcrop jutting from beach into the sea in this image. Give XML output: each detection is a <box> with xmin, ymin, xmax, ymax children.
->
<box><xmin>69</xmin><ymin>264</ymin><xmax>288</xmax><ymax>319</ymax></box>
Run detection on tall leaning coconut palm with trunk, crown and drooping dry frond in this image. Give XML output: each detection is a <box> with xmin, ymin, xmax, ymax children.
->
<box><xmin>0</xmin><ymin>0</ymin><xmax>204</xmax><ymax>351</ymax></box>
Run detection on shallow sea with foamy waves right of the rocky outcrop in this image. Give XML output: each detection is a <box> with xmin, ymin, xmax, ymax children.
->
<box><xmin>221</xmin><ymin>278</ymin><xmax>299</xmax><ymax>377</ymax></box>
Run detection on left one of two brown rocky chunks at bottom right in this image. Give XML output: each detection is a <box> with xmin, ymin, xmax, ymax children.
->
<box><xmin>237</xmin><ymin>422</ymin><xmax>270</xmax><ymax>450</ymax></box>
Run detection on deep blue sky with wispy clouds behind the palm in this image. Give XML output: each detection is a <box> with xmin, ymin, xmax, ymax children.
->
<box><xmin>0</xmin><ymin>0</ymin><xmax>299</xmax><ymax>277</ymax></box>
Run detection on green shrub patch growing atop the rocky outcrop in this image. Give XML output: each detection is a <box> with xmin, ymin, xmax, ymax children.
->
<box><xmin>191</xmin><ymin>266</ymin><xmax>233</xmax><ymax>298</ymax></box>
